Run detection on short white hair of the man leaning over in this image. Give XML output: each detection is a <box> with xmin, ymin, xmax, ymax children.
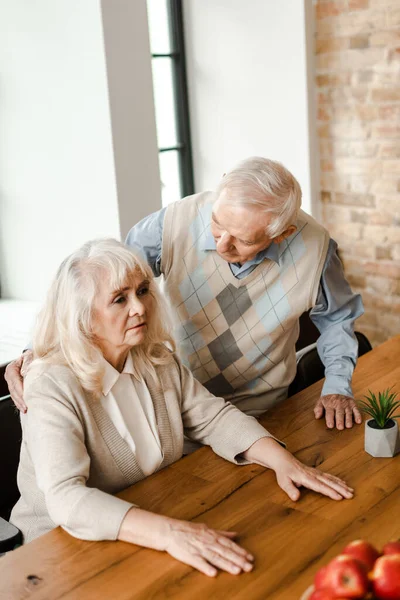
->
<box><xmin>216</xmin><ymin>156</ymin><xmax>301</xmax><ymax>238</ymax></box>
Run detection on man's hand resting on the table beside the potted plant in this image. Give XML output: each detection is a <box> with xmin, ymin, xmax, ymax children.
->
<box><xmin>314</xmin><ymin>394</ymin><xmax>362</xmax><ymax>429</ymax></box>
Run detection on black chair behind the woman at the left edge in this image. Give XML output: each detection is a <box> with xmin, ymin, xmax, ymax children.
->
<box><xmin>0</xmin><ymin>369</ymin><xmax>22</xmax><ymax>553</ymax></box>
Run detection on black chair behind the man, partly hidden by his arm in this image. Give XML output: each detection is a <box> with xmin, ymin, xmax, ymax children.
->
<box><xmin>288</xmin><ymin>313</ymin><xmax>372</xmax><ymax>396</ymax></box>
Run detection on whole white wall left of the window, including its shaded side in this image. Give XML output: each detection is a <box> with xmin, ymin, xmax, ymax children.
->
<box><xmin>0</xmin><ymin>0</ymin><xmax>161</xmax><ymax>300</ymax></box>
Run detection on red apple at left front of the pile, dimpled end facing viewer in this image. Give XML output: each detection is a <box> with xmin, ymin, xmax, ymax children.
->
<box><xmin>324</xmin><ymin>554</ymin><xmax>369</xmax><ymax>598</ymax></box>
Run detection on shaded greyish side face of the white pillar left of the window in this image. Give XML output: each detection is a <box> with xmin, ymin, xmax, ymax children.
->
<box><xmin>102</xmin><ymin>0</ymin><xmax>161</xmax><ymax>238</ymax></box>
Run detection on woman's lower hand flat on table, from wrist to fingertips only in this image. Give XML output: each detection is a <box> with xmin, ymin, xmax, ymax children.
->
<box><xmin>165</xmin><ymin>520</ymin><xmax>254</xmax><ymax>577</ymax></box>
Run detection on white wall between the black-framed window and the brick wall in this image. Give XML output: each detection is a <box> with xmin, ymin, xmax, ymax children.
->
<box><xmin>183</xmin><ymin>0</ymin><xmax>315</xmax><ymax>216</ymax></box>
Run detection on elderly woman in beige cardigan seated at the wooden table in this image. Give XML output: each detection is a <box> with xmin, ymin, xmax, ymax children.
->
<box><xmin>11</xmin><ymin>240</ymin><xmax>352</xmax><ymax>576</ymax></box>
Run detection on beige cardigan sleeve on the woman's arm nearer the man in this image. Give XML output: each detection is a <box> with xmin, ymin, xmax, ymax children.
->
<box><xmin>176</xmin><ymin>359</ymin><xmax>281</xmax><ymax>464</ymax></box>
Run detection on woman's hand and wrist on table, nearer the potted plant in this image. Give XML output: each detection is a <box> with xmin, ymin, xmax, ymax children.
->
<box><xmin>243</xmin><ymin>437</ymin><xmax>354</xmax><ymax>502</ymax></box>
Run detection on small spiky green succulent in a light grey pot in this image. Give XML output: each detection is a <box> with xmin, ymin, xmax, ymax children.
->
<box><xmin>358</xmin><ymin>388</ymin><xmax>400</xmax><ymax>458</ymax></box>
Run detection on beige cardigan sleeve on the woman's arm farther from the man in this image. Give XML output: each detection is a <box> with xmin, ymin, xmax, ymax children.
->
<box><xmin>21</xmin><ymin>374</ymin><xmax>133</xmax><ymax>540</ymax></box>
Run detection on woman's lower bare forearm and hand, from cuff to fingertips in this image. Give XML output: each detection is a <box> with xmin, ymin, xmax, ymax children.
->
<box><xmin>118</xmin><ymin>507</ymin><xmax>253</xmax><ymax>577</ymax></box>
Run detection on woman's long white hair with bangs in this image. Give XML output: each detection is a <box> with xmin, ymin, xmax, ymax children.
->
<box><xmin>33</xmin><ymin>239</ymin><xmax>175</xmax><ymax>395</ymax></box>
